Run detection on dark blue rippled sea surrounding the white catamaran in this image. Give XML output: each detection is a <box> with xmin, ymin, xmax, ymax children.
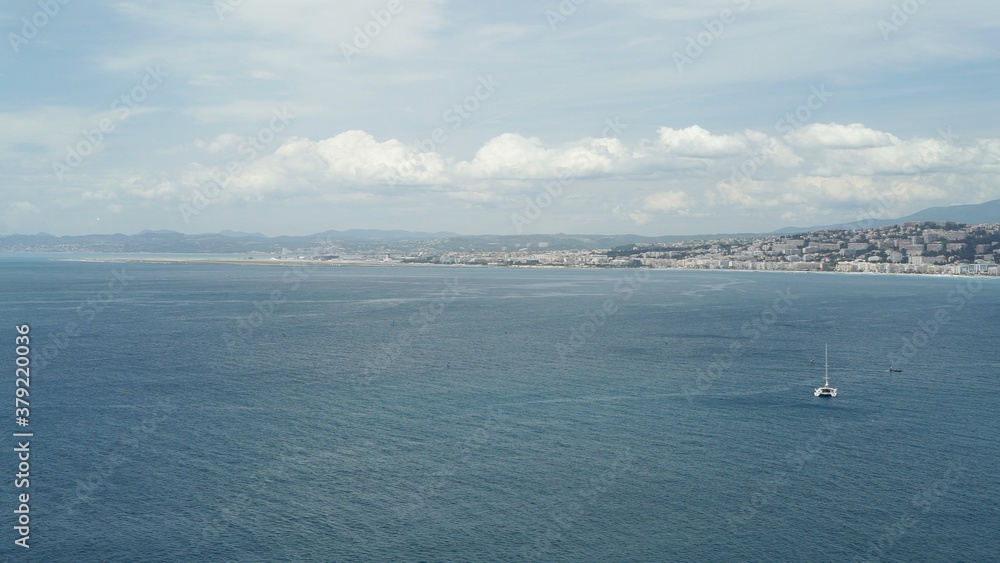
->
<box><xmin>0</xmin><ymin>254</ymin><xmax>1000</xmax><ymax>562</ymax></box>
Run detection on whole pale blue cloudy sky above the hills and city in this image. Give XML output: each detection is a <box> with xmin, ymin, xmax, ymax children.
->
<box><xmin>0</xmin><ymin>0</ymin><xmax>1000</xmax><ymax>236</ymax></box>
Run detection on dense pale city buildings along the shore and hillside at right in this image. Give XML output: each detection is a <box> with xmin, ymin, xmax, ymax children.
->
<box><xmin>388</xmin><ymin>222</ymin><xmax>1000</xmax><ymax>276</ymax></box>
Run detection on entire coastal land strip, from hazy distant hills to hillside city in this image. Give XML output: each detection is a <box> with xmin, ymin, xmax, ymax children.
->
<box><xmin>7</xmin><ymin>221</ymin><xmax>1000</xmax><ymax>276</ymax></box>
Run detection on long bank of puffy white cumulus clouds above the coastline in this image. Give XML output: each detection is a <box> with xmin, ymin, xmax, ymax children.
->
<box><xmin>158</xmin><ymin>123</ymin><xmax>1000</xmax><ymax>229</ymax></box>
